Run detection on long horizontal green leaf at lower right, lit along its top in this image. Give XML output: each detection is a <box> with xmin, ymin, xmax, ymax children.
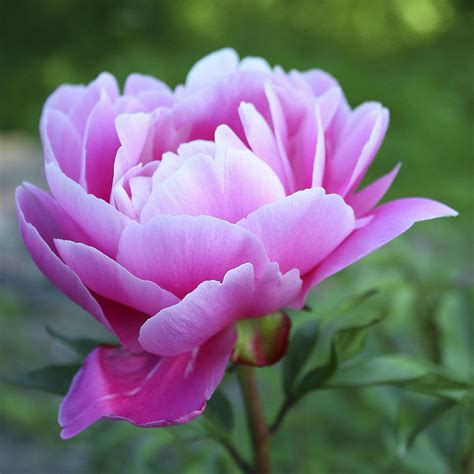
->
<box><xmin>325</xmin><ymin>355</ymin><xmax>470</xmax><ymax>400</ymax></box>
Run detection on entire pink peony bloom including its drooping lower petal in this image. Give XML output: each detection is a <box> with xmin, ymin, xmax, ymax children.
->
<box><xmin>17</xmin><ymin>49</ymin><xmax>456</xmax><ymax>438</ymax></box>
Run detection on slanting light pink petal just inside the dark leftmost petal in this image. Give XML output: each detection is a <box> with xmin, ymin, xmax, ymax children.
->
<box><xmin>45</xmin><ymin>163</ymin><xmax>129</xmax><ymax>256</ymax></box>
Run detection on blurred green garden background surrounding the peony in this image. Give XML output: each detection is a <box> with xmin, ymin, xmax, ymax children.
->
<box><xmin>0</xmin><ymin>0</ymin><xmax>474</xmax><ymax>474</ymax></box>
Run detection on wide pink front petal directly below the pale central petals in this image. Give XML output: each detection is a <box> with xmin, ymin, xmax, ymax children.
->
<box><xmin>117</xmin><ymin>216</ymin><xmax>267</xmax><ymax>297</ymax></box>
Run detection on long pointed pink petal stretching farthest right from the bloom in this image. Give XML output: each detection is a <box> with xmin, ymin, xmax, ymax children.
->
<box><xmin>296</xmin><ymin>198</ymin><xmax>457</xmax><ymax>306</ymax></box>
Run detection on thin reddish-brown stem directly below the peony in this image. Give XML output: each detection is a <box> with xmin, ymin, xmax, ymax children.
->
<box><xmin>237</xmin><ymin>365</ymin><xmax>270</xmax><ymax>474</ymax></box>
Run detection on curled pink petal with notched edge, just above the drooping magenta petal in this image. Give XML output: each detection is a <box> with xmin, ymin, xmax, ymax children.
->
<box><xmin>139</xmin><ymin>263</ymin><xmax>301</xmax><ymax>356</ymax></box>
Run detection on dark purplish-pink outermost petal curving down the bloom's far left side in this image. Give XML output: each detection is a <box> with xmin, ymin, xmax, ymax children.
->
<box><xmin>16</xmin><ymin>186</ymin><xmax>110</xmax><ymax>329</ymax></box>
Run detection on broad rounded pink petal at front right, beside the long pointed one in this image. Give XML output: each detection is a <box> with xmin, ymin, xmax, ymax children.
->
<box><xmin>239</xmin><ymin>188</ymin><xmax>354</xmax><ymax>275</ymax></box>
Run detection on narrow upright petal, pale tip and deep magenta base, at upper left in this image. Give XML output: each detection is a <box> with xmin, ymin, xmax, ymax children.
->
<box><xmin>83</xmin><ymin>94</ymin><xmax>120</xmax><ymax>201</ymax></box>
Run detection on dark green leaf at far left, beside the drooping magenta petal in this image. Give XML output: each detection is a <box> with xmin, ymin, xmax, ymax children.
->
<box><xmin>0</xmin><ymin>364</ymin><xmax>81</xmax><ymax>395</ymax></box>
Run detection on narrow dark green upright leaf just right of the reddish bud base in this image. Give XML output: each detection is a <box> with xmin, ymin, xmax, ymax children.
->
<box><xmin>282</xmin><ymin>320</ymin><xmax>319</xmax><ymax>394</ymax></box>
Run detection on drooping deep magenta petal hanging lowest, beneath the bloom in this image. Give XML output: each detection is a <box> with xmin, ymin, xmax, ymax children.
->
<box><xmin>59</xmin><ymin>329</ymin><xmax>235</xmax><ymax>439</ymax></box>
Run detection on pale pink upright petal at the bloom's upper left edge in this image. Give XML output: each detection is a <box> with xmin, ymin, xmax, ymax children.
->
<box><xmin>40</xmin><ymin>108</ymin><xmax>83</xmax><ymax>182</ymax></box>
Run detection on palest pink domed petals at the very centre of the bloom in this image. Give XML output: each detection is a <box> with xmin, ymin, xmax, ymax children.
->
<box><xmin>141</xmin><ymin>150</ymin><xmax>285</xmax><ymax>222</ymax></box>
